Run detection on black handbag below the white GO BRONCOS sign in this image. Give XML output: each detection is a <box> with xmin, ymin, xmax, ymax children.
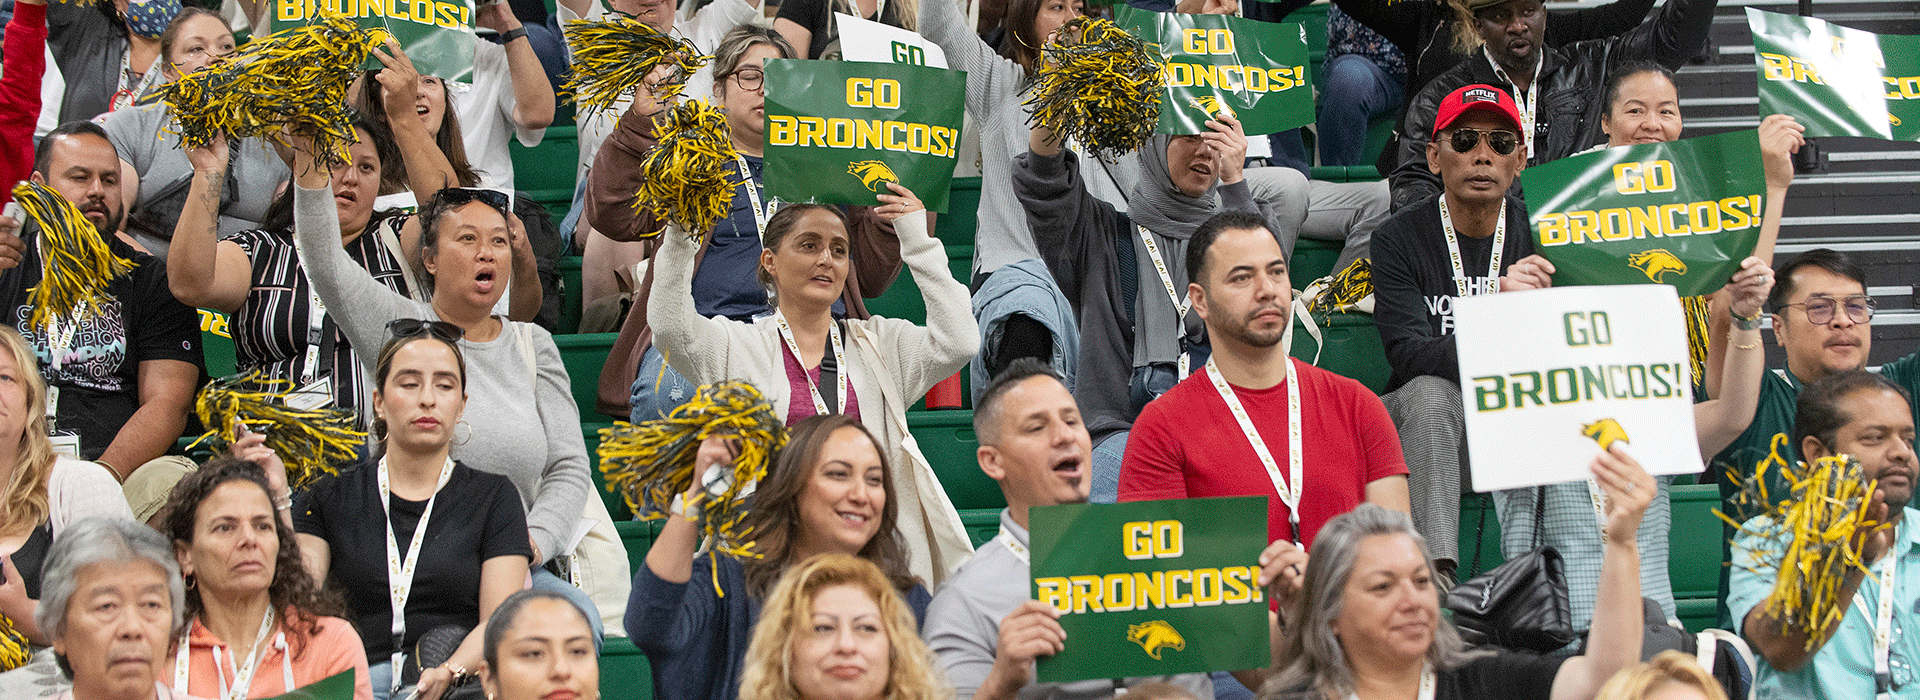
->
<box><xmin>1446</xmin><ymin>487</ymin><xmax>1578</xmax><ymax>654</ymax></box>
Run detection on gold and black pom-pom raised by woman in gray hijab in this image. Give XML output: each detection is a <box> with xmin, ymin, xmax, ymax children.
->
<box><xmin>1025</xmin><ymin>17</ymin><xmax>1167</xmax><ymax>157</ymax></box>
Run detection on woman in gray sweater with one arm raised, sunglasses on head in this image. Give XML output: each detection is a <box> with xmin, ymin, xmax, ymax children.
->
<box><xmin>294</xmin><ymin>129</ymin><xmax>606</xmax><ymax>635</ymax></box>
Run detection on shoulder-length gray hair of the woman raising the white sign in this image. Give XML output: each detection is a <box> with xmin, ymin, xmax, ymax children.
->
<box><xmin>1260</xmin><ymin>502</ymin><xmax>1490</xmax><ymax>698</ymax></box>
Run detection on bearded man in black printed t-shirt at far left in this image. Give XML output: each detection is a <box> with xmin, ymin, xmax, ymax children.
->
<box><xmin>0</xmin><ymin>121</ymin><xmax>204</xmax><ymax>479</ymax></box>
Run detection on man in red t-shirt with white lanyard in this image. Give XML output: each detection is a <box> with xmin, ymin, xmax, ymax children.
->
<box><xmin>1119</xmin><ymin>211</ymin><xmax>1407</xmax><ymax>547</ymax></box>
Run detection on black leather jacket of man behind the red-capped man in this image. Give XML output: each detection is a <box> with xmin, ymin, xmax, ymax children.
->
<box><xmin>1390</xmin><ymin>0</ymin><xmax>1718</xmax><ymax>211</ymax></box>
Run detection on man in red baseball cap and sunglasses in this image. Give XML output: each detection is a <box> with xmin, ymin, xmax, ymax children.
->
<box><xmin>1373</xmin><ymin>84</ymin><xmax>1553</xmax><ymax>572</ymax></box>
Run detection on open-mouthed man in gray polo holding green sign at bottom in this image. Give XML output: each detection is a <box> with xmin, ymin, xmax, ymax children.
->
<box><xmin>924</xmin><ymin>360</ymin><xmax>1205</xmax><ymax>700</ymax></box>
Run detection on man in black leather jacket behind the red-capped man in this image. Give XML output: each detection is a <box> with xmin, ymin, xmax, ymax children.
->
<box><xmin>1390</xmin><ymin>0</ymin><xmax>1718</xmax><ymax>211</ymax></box>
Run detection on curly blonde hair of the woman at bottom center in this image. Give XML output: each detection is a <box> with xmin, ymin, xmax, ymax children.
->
<box><xmin>739</xmin><ymin>554</ymin><xmax>952</xmax><ymax>700</ymax></box>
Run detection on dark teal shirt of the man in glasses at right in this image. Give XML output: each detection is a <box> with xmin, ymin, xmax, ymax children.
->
<box><xmin>1707</xmin><ymin>351</ymin><xmax>1920</xmax><ymax>625</ymax></box>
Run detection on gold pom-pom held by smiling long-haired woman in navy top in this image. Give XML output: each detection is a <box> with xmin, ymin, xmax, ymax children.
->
<box><xmin>599</xmin><ymin>382</ymin><xmax>787</xmax><ymax>595</ymax></box>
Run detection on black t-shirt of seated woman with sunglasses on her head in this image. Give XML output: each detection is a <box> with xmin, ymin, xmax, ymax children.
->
<box><xmin>294</xmin><ymin>462</ymin><xmax>534</xmax><ymax>664</ymax></box>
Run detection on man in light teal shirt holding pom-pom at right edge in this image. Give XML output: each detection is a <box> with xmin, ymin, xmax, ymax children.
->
<box><xmin>1728</xmin><ymin>370</ymin><xmax>1920</xmax><ymax>698</ymax></box>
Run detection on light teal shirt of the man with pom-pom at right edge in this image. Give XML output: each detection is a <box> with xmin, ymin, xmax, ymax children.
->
<box><xmin>1728</xmin><ymin>506</ymin><xmax>1920</xmax><ymax>700</ymax></box>
